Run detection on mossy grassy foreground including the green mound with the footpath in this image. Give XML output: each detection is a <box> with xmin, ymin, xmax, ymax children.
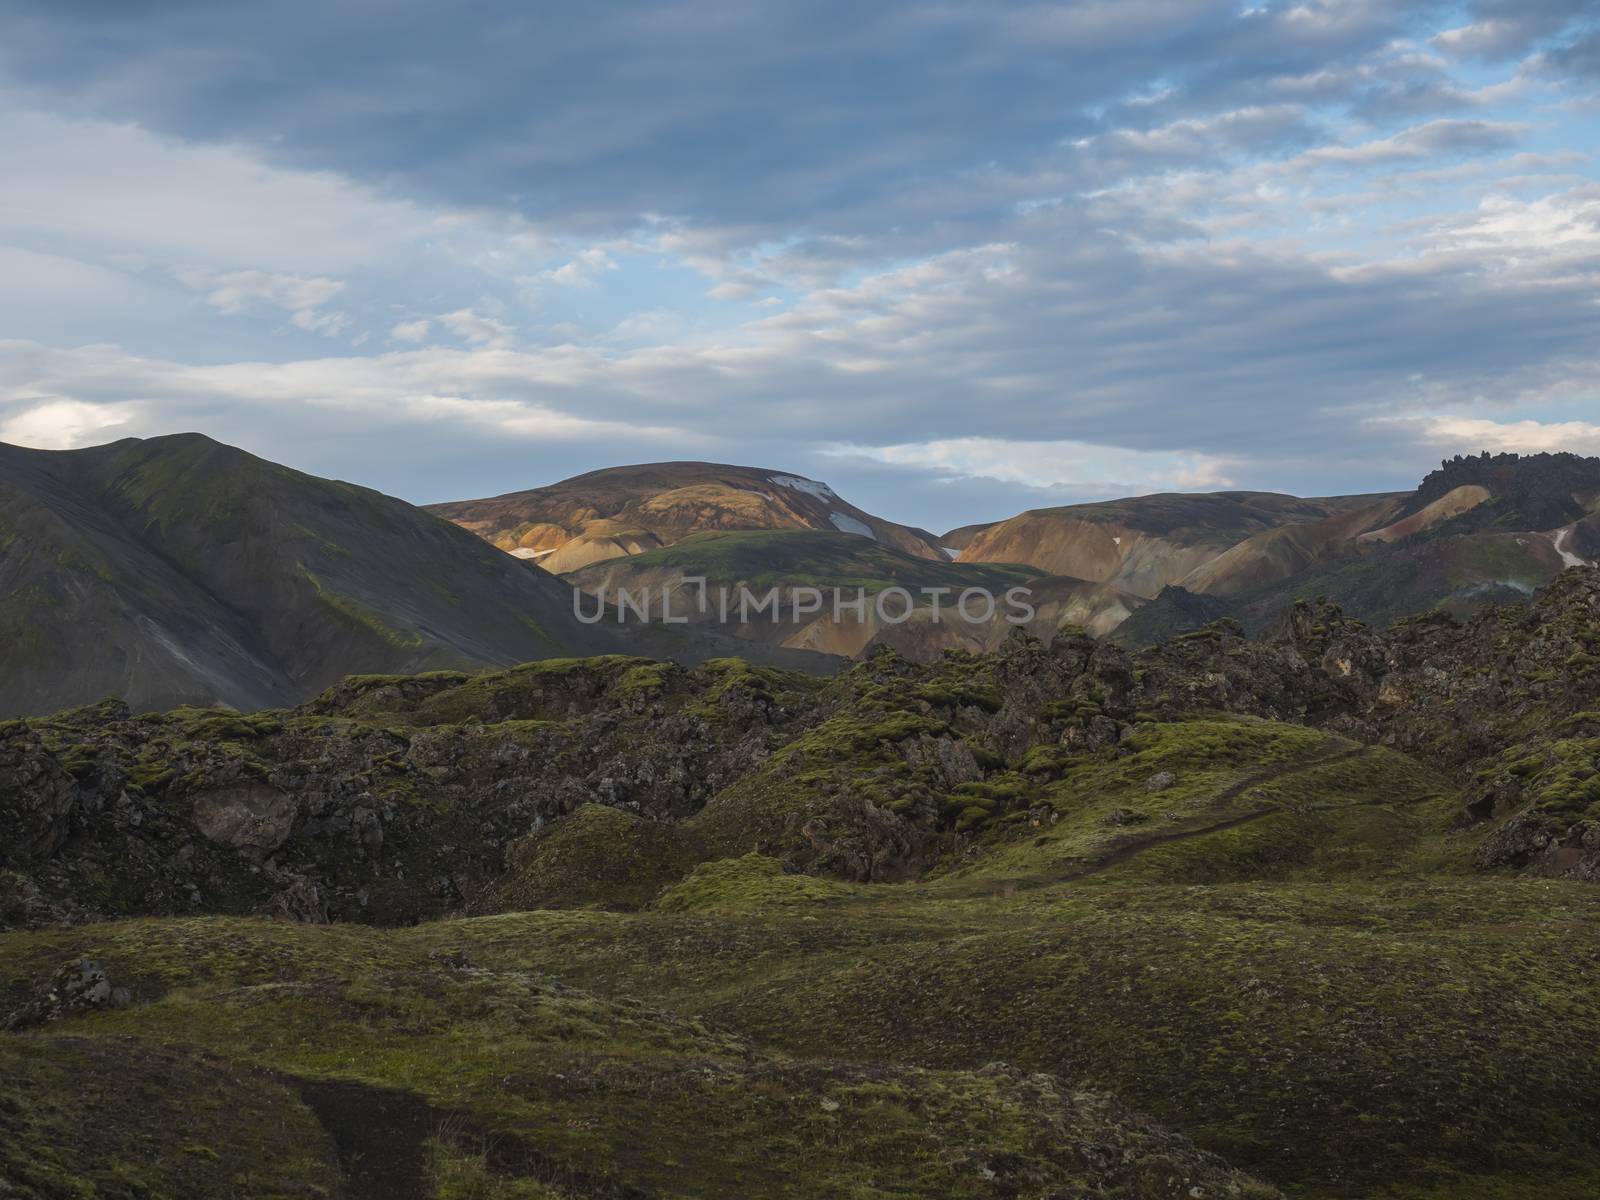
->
<box><xmin>0</xmin><ymin>720</ymin><xmax>1600</xmax><ymax>1200</ymax></box>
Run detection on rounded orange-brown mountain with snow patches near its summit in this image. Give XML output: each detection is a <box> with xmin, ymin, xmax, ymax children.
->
<box><xmin>429</xmin><ymin>462</ymin><xmax>949</xmax><ymax>574</ymax></box>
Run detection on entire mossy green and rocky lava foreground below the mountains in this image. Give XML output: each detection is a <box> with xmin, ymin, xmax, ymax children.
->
<box><xmin>15</xmin><ymin>570</ymin><xmax>1600</xmax><ymax>1200</ymax></box>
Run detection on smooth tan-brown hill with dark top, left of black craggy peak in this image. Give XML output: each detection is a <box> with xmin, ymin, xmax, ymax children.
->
<box><xmin>958</xmin><ymin>491</ymin><xmax>1373</xmax><ymax>598</ymax></box>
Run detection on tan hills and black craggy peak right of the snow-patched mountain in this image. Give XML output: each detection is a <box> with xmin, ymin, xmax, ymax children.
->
<box><xmin>952</xmin><ymin>454</ymin><xmax>1600</xmax><ymax>643</ymax></box>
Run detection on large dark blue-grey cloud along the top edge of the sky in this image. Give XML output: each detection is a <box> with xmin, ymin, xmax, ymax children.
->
<box><xmin>0</xmin><ymin>0</ymin><xmax>1429</xmax><ymax>241</ymax></box>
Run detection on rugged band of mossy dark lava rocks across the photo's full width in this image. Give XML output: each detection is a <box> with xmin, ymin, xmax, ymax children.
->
<box><xmin>9</xmin><ymin>568</ymin><xmax>1600</xmax><ymax>925</ymax></box>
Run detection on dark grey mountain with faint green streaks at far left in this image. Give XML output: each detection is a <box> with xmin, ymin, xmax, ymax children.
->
<box><xmin>0</xmin><ymin>434</ymin><xmax>608</xmax><ymax>714</ymax></box>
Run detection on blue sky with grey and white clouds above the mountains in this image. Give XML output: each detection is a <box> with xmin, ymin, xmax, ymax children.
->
<box><xmin>0</xmin><ymin>0</ymin><xmax>1600</xmax><ymax>531</ymax></box>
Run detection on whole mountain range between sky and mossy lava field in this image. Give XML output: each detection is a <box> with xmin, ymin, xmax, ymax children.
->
<box><xmin>0</xmin><ymin>434</ymin><xmax>1600</xmax><ymax>715</ymax></box>
